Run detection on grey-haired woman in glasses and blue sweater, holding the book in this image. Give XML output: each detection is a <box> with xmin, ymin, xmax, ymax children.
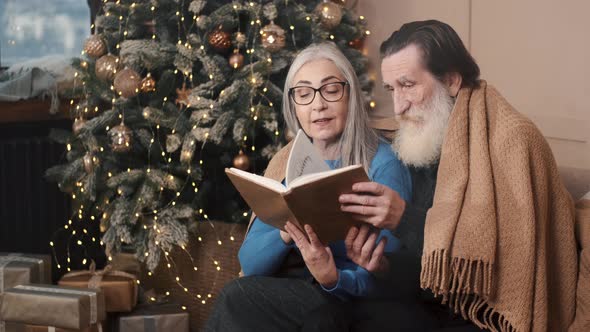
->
<box><xmin>206</xmin><ymin>43</ymin><xmax>411</xmax><ymax>331</ymax></box>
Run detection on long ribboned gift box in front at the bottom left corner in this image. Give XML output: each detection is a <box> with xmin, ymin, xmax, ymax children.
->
<box><xmin>0</xmin><ymin>284</ymin><xmax>106</xmax><ymax>330</ymax></box>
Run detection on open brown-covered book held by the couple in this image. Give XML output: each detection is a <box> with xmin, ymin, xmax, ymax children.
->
<box><xmin>225</xmin><ymin>130</ymin><xmax>369</xmax><ymax>244</ymax></box>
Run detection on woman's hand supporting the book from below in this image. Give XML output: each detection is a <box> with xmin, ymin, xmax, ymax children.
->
<box><xmin>285</xmin><ymin>222</ymin><xmax>338</xmax><ymax>289</ymax></box>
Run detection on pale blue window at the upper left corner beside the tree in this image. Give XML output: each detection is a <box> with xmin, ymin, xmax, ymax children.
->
<box><xmin>0</xmin><ymin>0</ymin><xmax>90</xmax><ymax>67</ymax></box>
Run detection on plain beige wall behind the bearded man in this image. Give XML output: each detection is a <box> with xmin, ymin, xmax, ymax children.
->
<box><xmin>356</xmin><ymin>0</ymin><xmax>590</xmax><ymax>169</ymax></box>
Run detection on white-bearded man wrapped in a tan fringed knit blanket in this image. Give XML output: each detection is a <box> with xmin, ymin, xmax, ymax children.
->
<box><xmin>340</xmin><ymin>21</ymin><xmax>577</xmax><ymax>331</ymax></box>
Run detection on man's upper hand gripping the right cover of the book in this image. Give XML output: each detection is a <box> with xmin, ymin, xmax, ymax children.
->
<box><xmin>339</xmin><ymin>182</ymin><xmax>406</xmax><ymax>230</ymax></box>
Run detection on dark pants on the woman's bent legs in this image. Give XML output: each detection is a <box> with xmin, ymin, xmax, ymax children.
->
<box><xmin>205</xmin><ymin>276</ymin><xmax>345</xmax><ymax>332</ymax></box>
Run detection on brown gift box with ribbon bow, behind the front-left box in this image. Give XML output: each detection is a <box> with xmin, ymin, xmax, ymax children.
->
<box><xmin>58</xmin><ymin>266</ymin><xmax>138</xmax><ymax>312</ymax></box>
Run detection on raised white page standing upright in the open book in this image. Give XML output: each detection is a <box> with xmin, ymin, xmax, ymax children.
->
<box><xmin>285</xmin><ymin>129</ymin><xmax>330</xmax><ymax>187</ymax></box>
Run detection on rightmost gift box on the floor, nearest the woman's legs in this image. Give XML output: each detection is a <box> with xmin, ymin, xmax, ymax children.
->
<box><xmin>116</xmin><ymin>304</ymin><xmax>189</xmax><ymax>332</ymax></box>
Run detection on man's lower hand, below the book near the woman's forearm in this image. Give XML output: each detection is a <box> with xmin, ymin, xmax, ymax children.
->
<box><xmin>344</xmin><ymin>225</ymin><xmax>389</xmax><ymax>276</ymax></box>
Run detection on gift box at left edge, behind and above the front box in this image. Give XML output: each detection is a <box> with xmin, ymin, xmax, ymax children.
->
<box><xmin>0</xmin><ymin>253</ymin><xmax>51</xmax><ymax>293</ymax></box>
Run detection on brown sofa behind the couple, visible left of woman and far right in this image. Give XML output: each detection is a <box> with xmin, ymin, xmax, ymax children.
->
<box><xmin>141</xmin><ymin>160</ymin><xmax>590</xmax><ymax>331</ymax></box>
